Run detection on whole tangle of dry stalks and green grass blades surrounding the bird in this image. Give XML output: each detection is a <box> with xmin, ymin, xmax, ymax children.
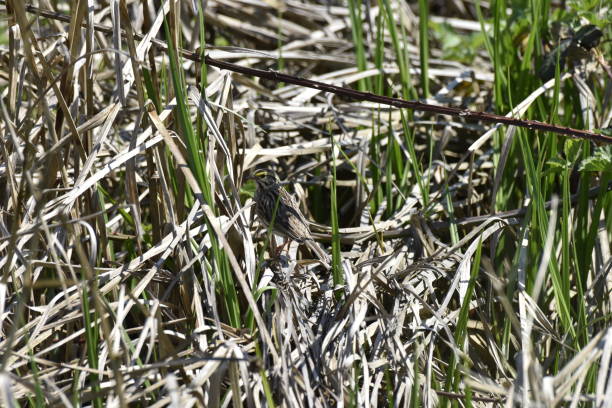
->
<box><xmin>0</xmin><ymin>0</ymin><xmax>612</xmax><ymax>407</ymax></box>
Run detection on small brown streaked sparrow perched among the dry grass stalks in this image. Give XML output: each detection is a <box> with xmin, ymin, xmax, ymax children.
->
<box><xmin>250</xmin><ymin>169</ymin><xmax>330</xmax><ymax>267</ymax></box>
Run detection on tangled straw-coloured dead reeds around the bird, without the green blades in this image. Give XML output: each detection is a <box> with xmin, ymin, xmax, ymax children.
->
<box><xmin>0</xmin><ymin>0</ymin><xmax>611</xmax><ymax>406</ymax></box>
